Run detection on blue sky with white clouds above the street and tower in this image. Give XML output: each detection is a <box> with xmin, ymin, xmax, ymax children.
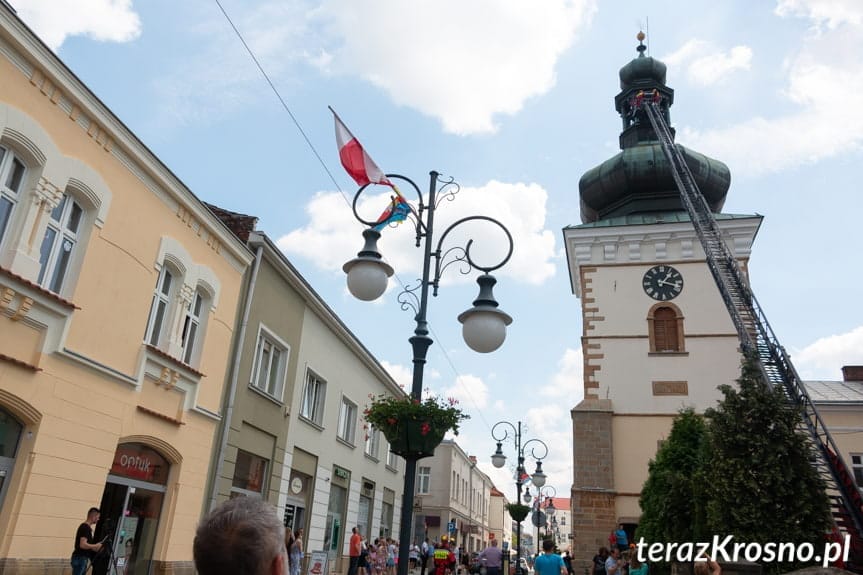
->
<box><xmin>11</xmin><ymin>0</ymin><xmax>863</xmax><ymax>504</ymax></box>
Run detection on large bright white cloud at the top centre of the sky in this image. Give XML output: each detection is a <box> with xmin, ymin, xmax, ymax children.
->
<box><xmin>318</xmin><ymin>0</ymin><xmax>596</xmax><ymax>134</ymax></box>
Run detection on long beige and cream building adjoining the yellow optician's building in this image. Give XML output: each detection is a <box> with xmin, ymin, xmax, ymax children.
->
<box><xmin>201</xmin><ymin>212</ymin><xmax>404</xmax><ymax>571</ymax></box>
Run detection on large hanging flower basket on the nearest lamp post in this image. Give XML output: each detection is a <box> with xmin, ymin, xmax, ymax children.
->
<box><xmin>363</xmin><ymin>395</ymin><xmax>468</xmax><ymax>459</ymax></box>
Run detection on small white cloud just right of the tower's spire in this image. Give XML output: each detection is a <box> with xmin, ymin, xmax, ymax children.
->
<box><xmin>661</xmin><ymin>38</ymin><xmax>752</xmax><ymax>86</ymax></box>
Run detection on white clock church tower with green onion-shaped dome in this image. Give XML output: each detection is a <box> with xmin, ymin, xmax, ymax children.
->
<box><xmin>563</xmin><ymin>34</ymin><xmax>761</xmax><ymax>565</ymax></box>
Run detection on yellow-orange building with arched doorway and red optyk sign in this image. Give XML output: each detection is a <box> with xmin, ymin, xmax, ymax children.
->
<box><xmin>0</xmin><ymin>3</ymin><xmax>251</xmax><ymax>573</ymax></box>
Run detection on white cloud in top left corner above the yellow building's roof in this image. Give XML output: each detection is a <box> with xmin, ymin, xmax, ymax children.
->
<box><xmin>14</xmin><ymin>0</ymin><xmax>141</xmax><ymax>51</ymax></box>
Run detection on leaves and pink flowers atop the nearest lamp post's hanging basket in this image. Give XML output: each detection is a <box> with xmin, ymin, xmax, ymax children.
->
<box><xmin>363</xmin><ymin>394</ymin><xmax>470</xmax><ymax>435</ymax></box>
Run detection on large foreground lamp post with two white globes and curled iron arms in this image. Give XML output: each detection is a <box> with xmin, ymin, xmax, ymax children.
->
<box><xmin>342</xmin><ymin>171</ymin><xmax>513</xmax><ymax>575</ymax></box>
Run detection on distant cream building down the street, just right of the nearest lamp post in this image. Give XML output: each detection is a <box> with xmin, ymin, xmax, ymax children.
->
<box><xmin>414</xmin><ymin>439</ymin><xmax>496</xmax><ymax>553</ymax></box>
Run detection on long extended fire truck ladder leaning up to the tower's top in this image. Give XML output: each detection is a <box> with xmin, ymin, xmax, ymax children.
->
<box><xmin>642</xmin><ymin>101</ymin><xmax>863</xmax><ymax>573</ymax></box>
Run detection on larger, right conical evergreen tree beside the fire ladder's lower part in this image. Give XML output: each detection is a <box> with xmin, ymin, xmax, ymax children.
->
<box><xmin>700</xmin><ymin>359</ymin><xmax>831</xmax><ymax>571</ymax></box>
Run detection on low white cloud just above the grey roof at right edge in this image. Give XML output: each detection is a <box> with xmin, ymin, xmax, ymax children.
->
<box><xmin>791</xmin><ymin>325</ymin><xmax>863</xmax><ymax>380</ymax></box>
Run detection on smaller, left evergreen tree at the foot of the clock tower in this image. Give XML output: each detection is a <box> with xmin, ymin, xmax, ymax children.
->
<box><xmin>635</xmin><ymin>409</ymin><xmax>707</xmax><ymax>543</ymax></box>
